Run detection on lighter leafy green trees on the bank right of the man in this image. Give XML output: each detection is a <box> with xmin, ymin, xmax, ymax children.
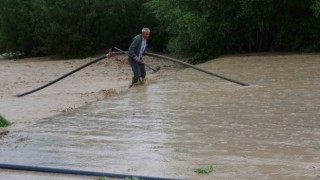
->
<box><xmin>147</xmin><ymin>0</ymin><xmax>320</xmax><ymax>61</ymax></box>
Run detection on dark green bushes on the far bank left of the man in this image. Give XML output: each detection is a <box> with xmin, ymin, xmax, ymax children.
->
<box><xmin>0</xmin><ymin>0</ymin><xmax>141</xmax><ymax>57</ymax></box>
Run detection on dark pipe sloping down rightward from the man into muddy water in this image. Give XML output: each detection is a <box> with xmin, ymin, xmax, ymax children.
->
<box><xmin>144</xmin><ymin>52</ymin><xmax>249</xmax><ymax>86</ymax></box>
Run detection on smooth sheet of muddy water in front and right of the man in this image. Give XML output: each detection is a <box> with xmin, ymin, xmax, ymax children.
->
<box><xmin>0</xmin><ymin>55</ymin><xmax>320</xmax><ymax>179</ymax></box>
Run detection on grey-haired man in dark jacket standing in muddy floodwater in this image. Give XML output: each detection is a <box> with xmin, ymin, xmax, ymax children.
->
<box><xmin>129</xmin><ymin>27</ymin><xmax>150</xmax><ymax>87</ymax></box>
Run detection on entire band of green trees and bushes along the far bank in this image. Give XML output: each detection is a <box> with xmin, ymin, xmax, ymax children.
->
<box><xmin>0</xmin><ymin>0</ymin><xmax>320</xmax><ymax>59</ymax></box>
